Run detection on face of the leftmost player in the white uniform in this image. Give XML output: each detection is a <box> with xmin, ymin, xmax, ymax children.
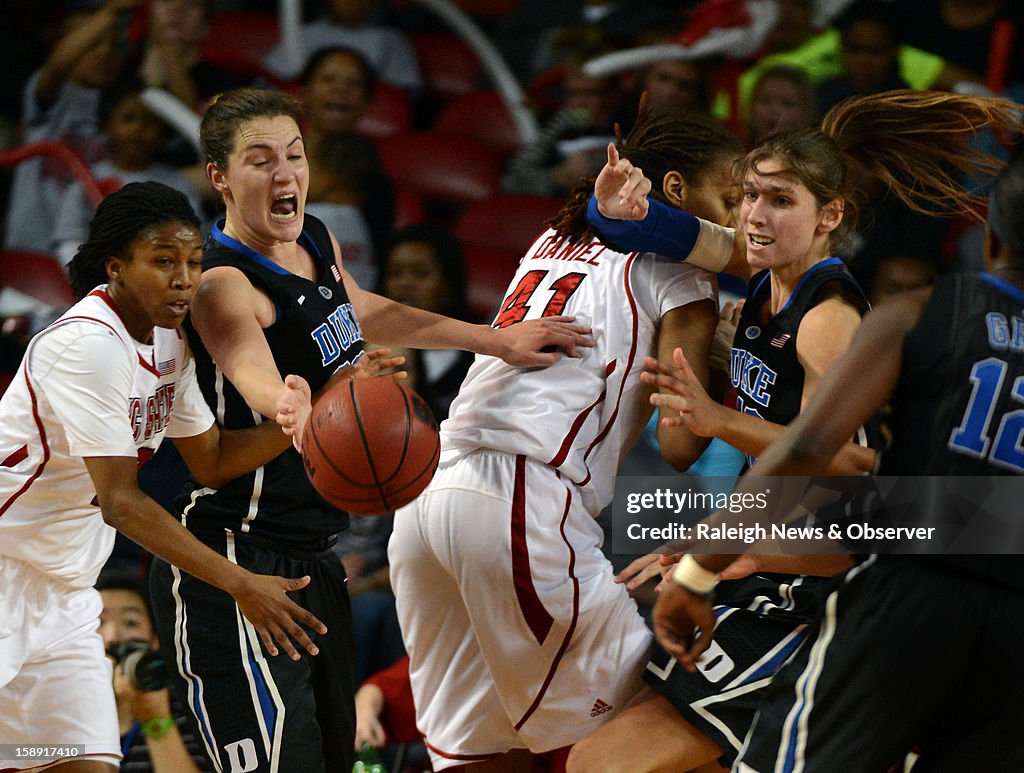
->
<box><xmin>106</xmin><ymin>221</ymin><xmax>203</xmax><ymax>343</ymax></box>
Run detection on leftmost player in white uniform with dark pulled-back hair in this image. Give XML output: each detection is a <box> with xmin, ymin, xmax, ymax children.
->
<box><xmin>0</xmin><ymin>182</ymin><xmax>324</xmax><ymax>773</ymax></box>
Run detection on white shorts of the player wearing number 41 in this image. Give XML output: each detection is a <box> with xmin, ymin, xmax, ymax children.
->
<box><xmin>388</xmin><ymin>452</ymin><xmax>651</xmax><ymax>770</ymax></box>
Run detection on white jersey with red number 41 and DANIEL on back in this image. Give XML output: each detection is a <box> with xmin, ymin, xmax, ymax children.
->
<box><xmin>441</xmin><ymin>229</ymin><xmax>718</xmax><ymax>515</ymax></box>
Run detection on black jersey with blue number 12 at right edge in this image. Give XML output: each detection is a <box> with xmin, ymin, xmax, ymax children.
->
<box><xmin>880</xmin><ymin>273</ymin><xmax>1024</xmax><ymax>475</ymax></box>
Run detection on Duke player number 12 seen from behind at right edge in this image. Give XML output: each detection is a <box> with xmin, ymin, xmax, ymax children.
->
<box><xmin>655</xmin><ymin>140</ymin><xmax>1024</xmax><ymax>773</ymax></box>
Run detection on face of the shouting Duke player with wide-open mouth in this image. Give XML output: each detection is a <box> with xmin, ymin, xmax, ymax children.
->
<box><xmin>215</xmin><ymin>116</ymin><xmax>309</xmax><ymax>251</ymax></box>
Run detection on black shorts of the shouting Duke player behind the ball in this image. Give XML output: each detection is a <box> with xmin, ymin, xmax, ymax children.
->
<box><xmin>151</xmin><ymin>535</ymin><xmax>355</xmax><ymax>773</ymax></box>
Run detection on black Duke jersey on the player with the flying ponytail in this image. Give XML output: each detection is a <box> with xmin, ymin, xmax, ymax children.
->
<box><xmin>730</xmin><ymin>258</ymin><xmax>867</xmax><ymax>464</ymax></box>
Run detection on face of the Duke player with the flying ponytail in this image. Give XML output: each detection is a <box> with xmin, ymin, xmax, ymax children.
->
<box><xmin>739</xmin><ymin>159</ymin><xmax>828</xmax><ymax>270</ymax></box>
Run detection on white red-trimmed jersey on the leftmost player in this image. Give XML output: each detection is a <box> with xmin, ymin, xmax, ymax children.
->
<box><xmin>0</xmin><ymin>288</ymin><xmax>213</xmax><ymax>588</ymax></box>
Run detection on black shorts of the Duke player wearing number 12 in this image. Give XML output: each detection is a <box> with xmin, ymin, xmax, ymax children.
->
<box><xmin>736</xmin><ymin>556</ymin><xmax>1024</xmax><ymax>773</ymax></box>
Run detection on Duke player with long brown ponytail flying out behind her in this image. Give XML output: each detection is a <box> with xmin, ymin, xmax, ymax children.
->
<box><xmin>572</xmin><ymin>87</ymin><xmax>1010</xmax><ymax>771</ymax></box>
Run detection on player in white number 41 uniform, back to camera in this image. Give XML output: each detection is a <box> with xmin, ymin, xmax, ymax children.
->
<box><xmin>378</xmin><ymin>101</ymin><xmax>739</xmax><ymax>772</ymax></box>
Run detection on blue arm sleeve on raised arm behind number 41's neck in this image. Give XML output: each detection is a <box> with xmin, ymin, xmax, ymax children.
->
<box><xmin>587</xmin><ymin>196</ymin><xmax>734</xmax><ymax>271</ymax></box>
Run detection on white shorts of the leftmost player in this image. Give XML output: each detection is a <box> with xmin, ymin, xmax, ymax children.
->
<box><xmin>0</xmin><ymin>556</ymin><xmax>121</xmax><ymax>769</ymax></box>
